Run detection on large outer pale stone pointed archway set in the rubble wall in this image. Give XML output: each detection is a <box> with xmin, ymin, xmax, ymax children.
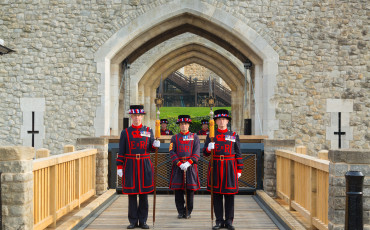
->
<box><xmin>94</xmin><ymin>0</ymin><xmax>279</xmax><ymax>138</ymax></box>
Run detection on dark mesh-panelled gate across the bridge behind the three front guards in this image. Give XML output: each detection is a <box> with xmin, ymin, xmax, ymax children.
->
<box><xmin>108</xmin><ymin>143</ymin><xmax>263</xmax><ymax>193</ymax></box>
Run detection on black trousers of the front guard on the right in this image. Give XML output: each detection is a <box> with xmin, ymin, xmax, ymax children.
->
<box><xmin>213</xmin><ymin>193</ymin><xmax>234</xmax><ymax>225</ymax></box>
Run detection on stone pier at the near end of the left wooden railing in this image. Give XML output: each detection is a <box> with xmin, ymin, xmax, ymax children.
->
<box><xmin>0</xmin><ymin>147</ymin><xmax>35</xmax><ymax>230</ymax></box>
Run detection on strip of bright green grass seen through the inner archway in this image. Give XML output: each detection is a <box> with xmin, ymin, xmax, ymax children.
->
<box><xmin>160</xmin><ymin>107</ymin><xmax>231</xmax><ymax>119</ymax></box>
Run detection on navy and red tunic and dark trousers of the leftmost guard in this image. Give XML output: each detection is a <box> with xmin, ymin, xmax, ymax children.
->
<box><xmin>116</xmin><ymin>125</ymin><xmax>154</xmax><ymax>225</ymax></box>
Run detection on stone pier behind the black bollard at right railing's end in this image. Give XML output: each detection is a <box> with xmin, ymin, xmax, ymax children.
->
<box><xmin>328</xmin><ymin>149</ymin><xmax>370</xmax><ymax>230</ymax></box>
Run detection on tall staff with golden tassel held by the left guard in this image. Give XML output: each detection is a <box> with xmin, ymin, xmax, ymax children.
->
<box><xmin>153</xmin><ymin>76</ymin><xmax>163</xmax><ymax>229</ymax></box>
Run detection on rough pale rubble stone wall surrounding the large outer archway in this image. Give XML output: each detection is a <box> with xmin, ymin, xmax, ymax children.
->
<box><xmin>0</xmin><ymin>0</ymin><xmax>370</xmax><ymax>154</ymax></box>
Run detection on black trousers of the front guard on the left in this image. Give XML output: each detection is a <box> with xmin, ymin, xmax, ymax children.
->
<box><xmin>128</xmin><ymin>194</ymin><xmax>149</xmax><ymax>224</ymax></box>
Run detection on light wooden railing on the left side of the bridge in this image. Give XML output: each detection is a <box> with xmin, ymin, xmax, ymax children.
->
<box><xmin>33</xmin><ymin>149</ymin><xmax>97</xmax><ymax>229</ymax></box>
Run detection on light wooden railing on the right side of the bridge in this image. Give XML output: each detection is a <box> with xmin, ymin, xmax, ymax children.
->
<box><xmin>276</xmin><ymin>150</ymin><xmax>329</xmax><ymax>229</ymax></box>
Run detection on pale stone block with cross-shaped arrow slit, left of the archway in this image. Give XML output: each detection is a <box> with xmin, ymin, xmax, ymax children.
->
<box><xmin>20</xmin><ymin>98</ymin><xmax>45</xmax><ymax>149</ymax></box>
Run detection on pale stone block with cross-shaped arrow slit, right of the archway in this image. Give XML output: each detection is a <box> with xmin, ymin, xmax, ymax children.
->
<box><xmin>326</xmin><ymin>99</ymin><xmax>353</xmax><ymax>149</ymax></box>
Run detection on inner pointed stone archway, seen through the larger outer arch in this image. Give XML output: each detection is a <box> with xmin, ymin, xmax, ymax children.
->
<box><xmin>138</xmin><ymin>44</ymin><xmax>244</xmax><ymax>132</ymax></box>
